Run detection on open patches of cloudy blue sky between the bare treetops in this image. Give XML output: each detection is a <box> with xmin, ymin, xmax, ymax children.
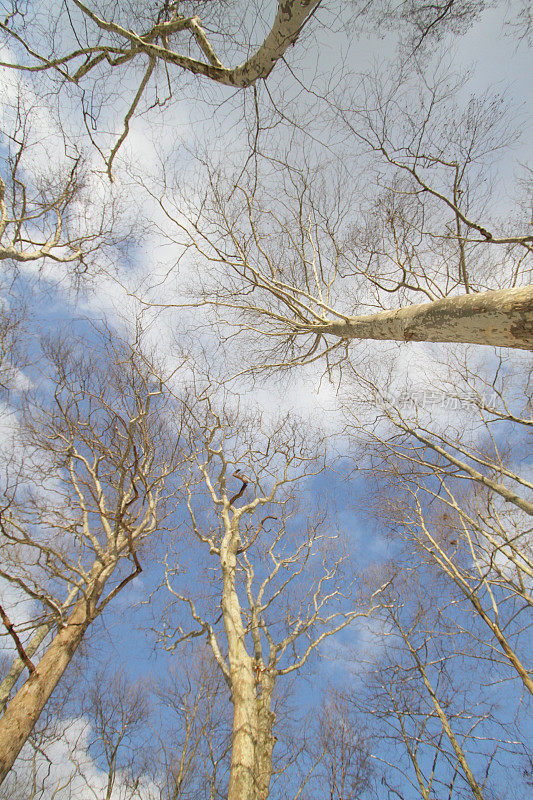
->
<box><xmin>0</xmin><ymin>3</ymin><xmax>533</xmax><ymax>800</ymax></box>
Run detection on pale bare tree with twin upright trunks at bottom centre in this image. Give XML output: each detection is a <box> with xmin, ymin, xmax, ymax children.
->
<box><xmin>160</xmin><ymin>409</ymin><xmax>388</xmax><ymax>800</ymax></box>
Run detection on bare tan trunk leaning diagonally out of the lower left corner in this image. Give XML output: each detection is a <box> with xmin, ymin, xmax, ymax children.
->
<box><xmin>0</xmin><ymin>565</ymin><xmax>111</xmax><ymax>784</ymax></box>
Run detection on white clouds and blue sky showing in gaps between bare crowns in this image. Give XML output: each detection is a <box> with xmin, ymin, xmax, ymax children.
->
<box><xmin>0</xmin><ymin>3</ymin><xmax>533</xmax><ymax>800</ymax></box>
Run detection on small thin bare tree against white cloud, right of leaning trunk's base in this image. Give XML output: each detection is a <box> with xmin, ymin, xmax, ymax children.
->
<box><xmin>2</xmin><ymin>648</ymin><xmax>153</xmax><ymax>800</ymax></box>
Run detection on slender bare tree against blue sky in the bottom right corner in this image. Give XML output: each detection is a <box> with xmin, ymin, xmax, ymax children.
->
<box><xmin>342</xmin><ymin>567</ymin><xmax>523</xmax><ymax>800</ymax></box>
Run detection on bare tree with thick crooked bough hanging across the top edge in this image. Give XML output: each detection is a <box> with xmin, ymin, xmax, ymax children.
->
<box><xmin>0</xmin><ymin>0</ymin><xmax>519</xmax><ymax>177</ymax></box>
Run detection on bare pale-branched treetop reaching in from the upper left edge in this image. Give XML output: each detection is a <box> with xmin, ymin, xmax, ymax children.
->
<box><xmin>0</xmin><ymin>93</ymin><xmax>126</xmax><ymax>279</ymax></box>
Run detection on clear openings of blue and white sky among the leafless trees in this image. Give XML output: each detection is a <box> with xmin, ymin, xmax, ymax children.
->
<box><xmin>0</xmin><ymin>3</ymin><xmax>533</xmax><ymax>800</ymax></box>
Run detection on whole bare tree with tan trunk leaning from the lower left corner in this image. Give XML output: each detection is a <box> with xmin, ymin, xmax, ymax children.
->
<box><xmin>0</xmin><ymin>328</ymin><xmax>184</xmax><ymax>780</ymax></box>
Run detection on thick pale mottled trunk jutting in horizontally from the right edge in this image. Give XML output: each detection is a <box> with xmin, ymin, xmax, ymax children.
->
<box><xmin>318</xmin><ymin>286</ymin><xmax>533</xmax><ymax>350</ymax></box>
